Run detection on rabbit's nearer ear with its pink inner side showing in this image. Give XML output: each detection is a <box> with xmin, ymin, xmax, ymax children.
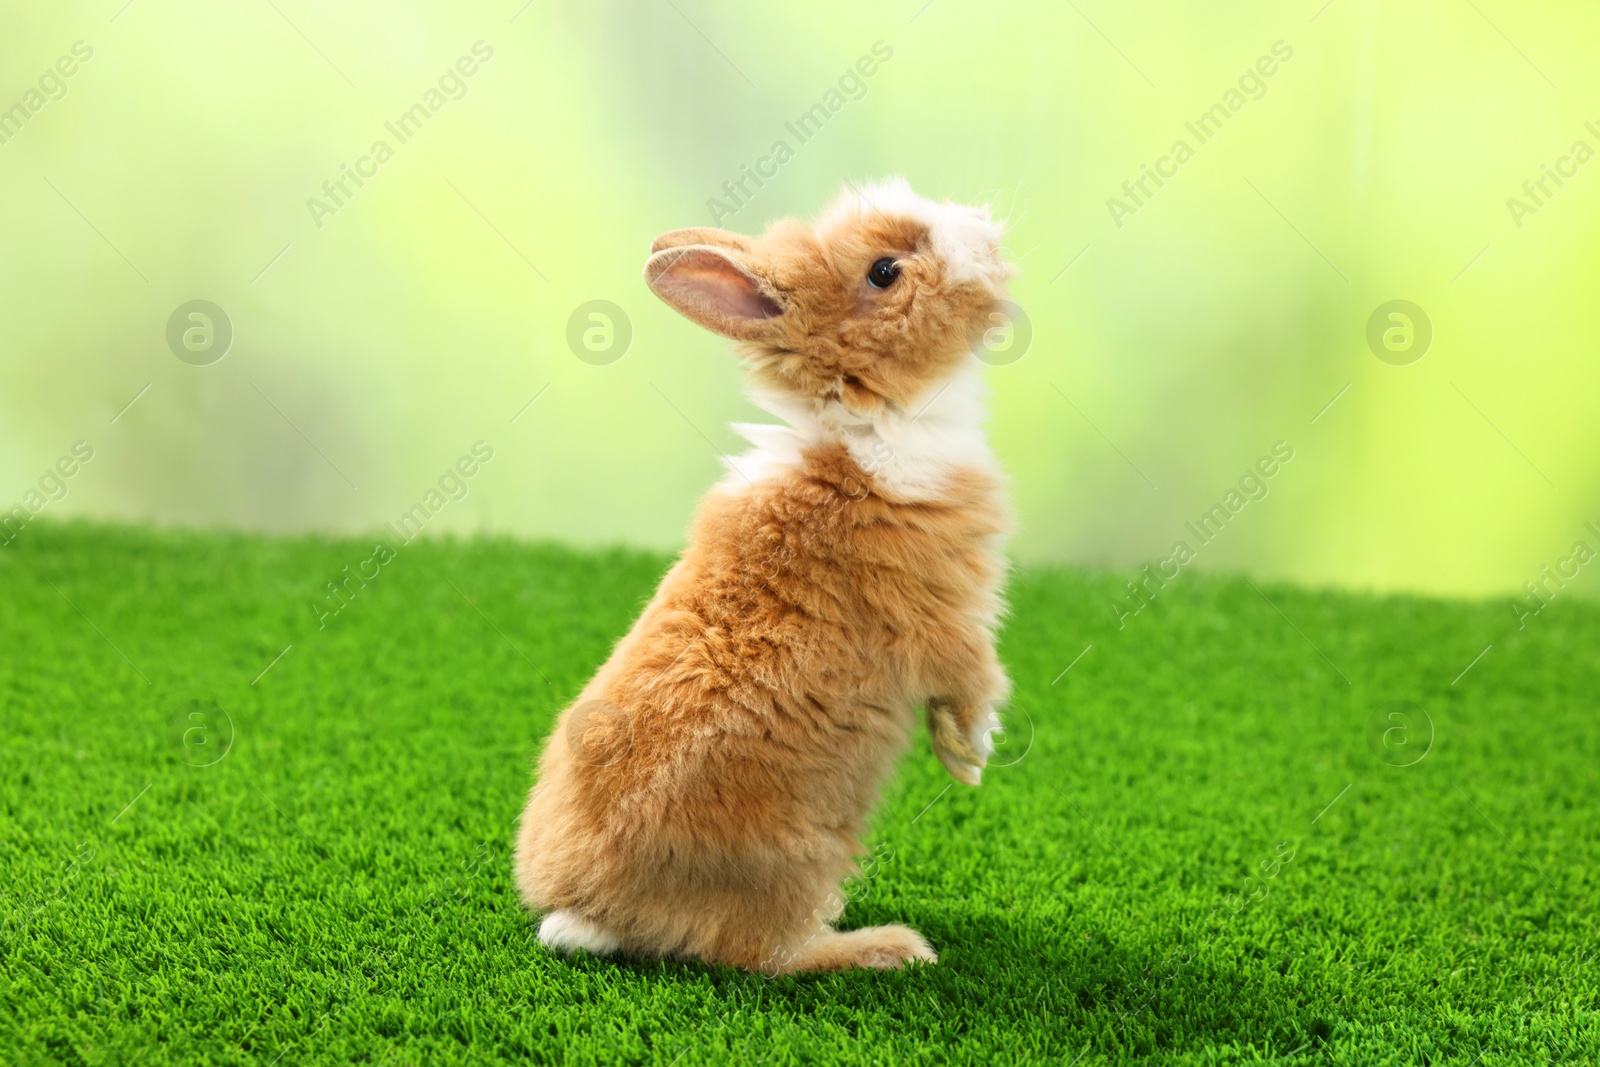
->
<box><xmin>645</xmin><ymin>245</ymin><xmax>784</xmax><ymax>341</ymax></box>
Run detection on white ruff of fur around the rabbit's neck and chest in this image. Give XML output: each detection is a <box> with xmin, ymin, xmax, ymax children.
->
<box><xmin>717</xmin><ymin>357</ymin><xmax>998</xmax><ymax>501</ymax></box>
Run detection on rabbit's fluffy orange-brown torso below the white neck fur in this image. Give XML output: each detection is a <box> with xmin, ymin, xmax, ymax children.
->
<box><xmin>518</xmin><ymin>450</ymin><xmax>1005</xmax><ymax>958</ymax></box>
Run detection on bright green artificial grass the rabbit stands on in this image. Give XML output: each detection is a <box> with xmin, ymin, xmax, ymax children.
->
<box><xmin>0</xmin><ymin>523</ymin><xmax>1600</xmax><ymax>1067</ymax></box>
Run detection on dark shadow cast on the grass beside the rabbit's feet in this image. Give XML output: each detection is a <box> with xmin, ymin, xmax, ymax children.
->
<box><xmin>537</xmin><ymin>917</ymin><xmax>1338</xmax><ymax>1064</ymax></box>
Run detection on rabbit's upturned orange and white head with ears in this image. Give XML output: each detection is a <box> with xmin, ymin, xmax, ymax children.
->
<box><xmin>645</xmin><ymin>179</ymin><xmax>1013</xmax><ymax>418</ymax></box>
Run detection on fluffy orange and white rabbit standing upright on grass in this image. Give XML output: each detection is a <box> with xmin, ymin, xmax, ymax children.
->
<box><xmin>515</xmin><ymin>179</ymin><xmax>1014</xmax><ymax>976</ymax></box>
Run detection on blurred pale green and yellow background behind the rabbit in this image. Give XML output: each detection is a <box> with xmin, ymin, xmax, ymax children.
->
<box><xmin>0</xmin><ymin>0</ymin><xmax>1600</xmax><ymax>593</ymax></box>
